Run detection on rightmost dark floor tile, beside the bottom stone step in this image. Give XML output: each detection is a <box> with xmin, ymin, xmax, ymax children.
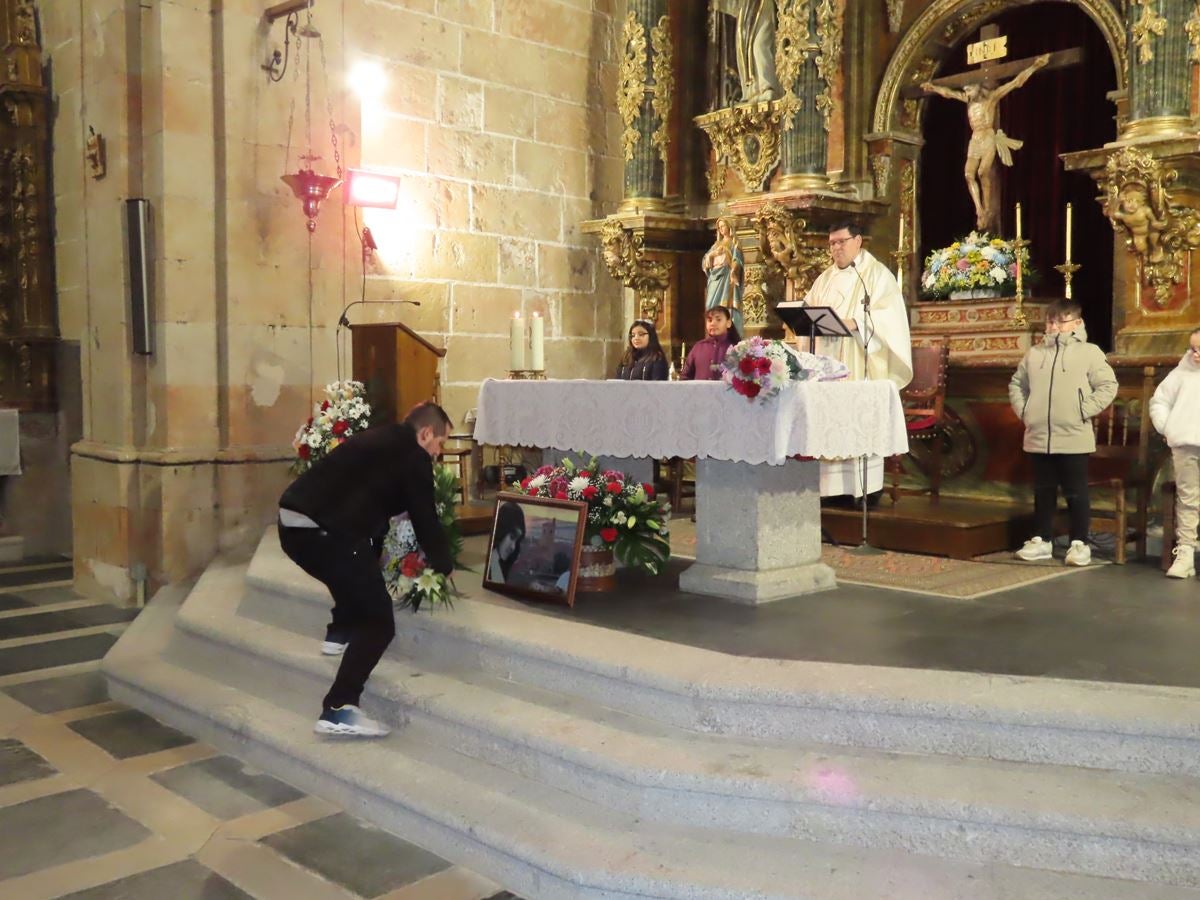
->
<box><xmin>262</xmin><ymin>812</ymin><xmax>450</xmax><ymax>896</ymax></box>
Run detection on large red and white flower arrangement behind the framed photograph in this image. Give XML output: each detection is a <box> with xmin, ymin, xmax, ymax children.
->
<box><xmin>511</xmin><ymin>460</ymin><xmax>671</xmax><ymax>575</ymax></box>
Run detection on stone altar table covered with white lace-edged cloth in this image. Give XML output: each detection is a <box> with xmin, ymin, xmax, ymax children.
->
<box><xmin>475</xmin><ymin>379</ymin><xmax>908</xmax><ymax>604</ymax></box>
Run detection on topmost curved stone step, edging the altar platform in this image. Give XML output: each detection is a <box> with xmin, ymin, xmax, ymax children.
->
<box><xmin>247</xmin><ymin>532</ymin><xmax>1200</xmax><ymax>778</ymax></box>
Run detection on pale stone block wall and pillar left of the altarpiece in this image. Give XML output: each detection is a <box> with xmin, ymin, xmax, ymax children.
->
<box><xmin>41</xmin><ymin>0</ymin><xmax>623</xmax><ymax>607</ymax></box>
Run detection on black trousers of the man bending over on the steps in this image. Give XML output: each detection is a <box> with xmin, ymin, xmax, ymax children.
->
<box><xmin>280</xmin><ymin>524</ymin><xmax>396</xmax><ymax>709</ymax></box>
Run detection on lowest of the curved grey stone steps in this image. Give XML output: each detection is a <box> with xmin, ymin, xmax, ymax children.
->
<box><xmin>104</xmin><ymin>584</ymin><xmax>1200</xmax><ymax>900</ymax></box>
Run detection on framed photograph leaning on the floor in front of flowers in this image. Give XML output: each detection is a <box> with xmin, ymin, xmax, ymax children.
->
<box><xmin>484</xmin><ymin>492</ymin><xmax>588</xmax><ymax>606</ymax></box>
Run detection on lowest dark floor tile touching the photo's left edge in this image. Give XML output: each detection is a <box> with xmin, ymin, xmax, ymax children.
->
<box><xmin>0</xmin><ymin>790</ymin><xmax>150</xmax><ymax>880</ymax></box>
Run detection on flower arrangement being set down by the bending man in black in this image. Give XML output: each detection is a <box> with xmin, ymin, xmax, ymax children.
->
<box><xmin>380</xmin><ymin>466</ymin><xmax>462</xmax><ymax>612</ymax></box>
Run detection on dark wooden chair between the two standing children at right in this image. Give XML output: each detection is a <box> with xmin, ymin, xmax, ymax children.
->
<box><xmin>1088</xmin><ymin>366</ymin><xmax>1157</xmax><ymax>565</ymax></box>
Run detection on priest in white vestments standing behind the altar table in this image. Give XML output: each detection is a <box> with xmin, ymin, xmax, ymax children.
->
<box><xmin>804</xmin><ymin>222</ymin><xmax>912</xmax><ymax>497</ymax></box>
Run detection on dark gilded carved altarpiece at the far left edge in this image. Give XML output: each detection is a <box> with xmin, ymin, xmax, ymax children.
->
<box><xmin>0</xmin><ymin>0</ymin><xmax>58</xmax><ymax>410</ymax></box>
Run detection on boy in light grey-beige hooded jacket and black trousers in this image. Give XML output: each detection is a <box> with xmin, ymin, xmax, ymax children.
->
<box><xmin>1008</xmin><ymin>300</ymin><xmax>1121</xmax><ymax>565</ymax></box>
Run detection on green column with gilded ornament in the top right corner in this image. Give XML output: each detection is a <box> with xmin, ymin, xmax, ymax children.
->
<box><xmin>1123</xmin><ymin>0</ymin><xmax>1200</xmax><ymax>137</ymax></box>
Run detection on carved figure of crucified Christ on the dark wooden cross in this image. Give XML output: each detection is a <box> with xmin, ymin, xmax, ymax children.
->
<box><xmin>920</xmin><ymin>53</ymin><xmax>1050</xmax><ymax>234</ymax></box>
